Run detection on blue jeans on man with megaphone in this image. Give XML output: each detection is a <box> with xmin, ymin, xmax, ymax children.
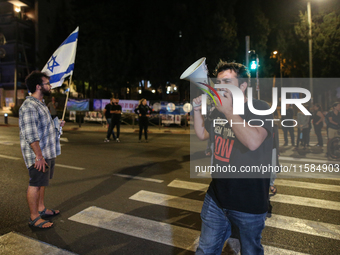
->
<box><xmin>196</xmin><ymin>194</ymin><xmax>267</xmax><ymax>255</ymax></box>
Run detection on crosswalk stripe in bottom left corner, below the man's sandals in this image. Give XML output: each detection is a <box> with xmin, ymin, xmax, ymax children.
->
<box><xmin>0</xmin><ymin>232</ymin><xmax>75</xmax><ymax>255</ymax></box>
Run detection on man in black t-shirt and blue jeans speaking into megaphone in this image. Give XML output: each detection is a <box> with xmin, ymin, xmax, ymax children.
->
<box><xmin>193</xmin><ymin>61</ymin><xmax>273</xmax><ymax>255</ymax></box>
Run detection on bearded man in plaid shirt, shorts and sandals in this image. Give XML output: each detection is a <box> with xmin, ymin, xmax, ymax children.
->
<box><xmin>19</xmin><ymin>71</ymin><xmax>65</xmax><ymax>228</ymax></box>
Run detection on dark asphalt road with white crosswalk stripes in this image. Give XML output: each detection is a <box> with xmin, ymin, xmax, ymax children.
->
<box><xmin>0</xmin><ymin>126</ymin><xmax>340</xmax><ymax>255</ymax></box>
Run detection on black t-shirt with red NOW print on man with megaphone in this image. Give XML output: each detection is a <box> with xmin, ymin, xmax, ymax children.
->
<box><xmin>208</xmin><ymin>99</ymin><xmax>273</xmax><ymax>214</ymax></box>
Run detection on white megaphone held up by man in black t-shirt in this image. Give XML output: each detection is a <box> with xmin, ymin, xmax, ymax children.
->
<box><xmin>180</xmin><ymin>57</ymin><xmax>223</xmax><ymax>111</ymax></box>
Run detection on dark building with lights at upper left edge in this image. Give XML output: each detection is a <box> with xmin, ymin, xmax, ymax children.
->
<box><xmin>0</xmin><ymin>0</ymin><xmax>35</xmax><ymax>108</ymax></box>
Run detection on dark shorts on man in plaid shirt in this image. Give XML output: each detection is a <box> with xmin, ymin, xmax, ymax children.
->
<box><xmin>28</xmin><ymin>158</ymin><xmax>55</xmax><ymax>187</ymax></box>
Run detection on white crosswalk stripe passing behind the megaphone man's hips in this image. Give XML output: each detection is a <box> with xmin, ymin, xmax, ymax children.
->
<box><xmin>130</xmin><ymin>190</ymin><xmax>340</xmax><ymax>240</ymax></box>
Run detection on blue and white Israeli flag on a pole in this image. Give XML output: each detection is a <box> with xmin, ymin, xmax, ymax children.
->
<box><xmin>41</xmin><ymin>27</ymin><xmax>79</xmax><ymax>89</ymax></box>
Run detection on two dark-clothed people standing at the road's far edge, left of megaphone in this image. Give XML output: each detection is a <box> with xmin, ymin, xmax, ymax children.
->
<box><xmin>103</xmin><ymin>98</ymin><xmax>152</xmax><ymax>143</ymax></box>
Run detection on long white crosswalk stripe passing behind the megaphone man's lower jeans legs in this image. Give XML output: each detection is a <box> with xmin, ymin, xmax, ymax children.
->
<box><xmin>69</xmin><ymin>206</ymin><xmax>307</xmax><ymax>255</ymax></box>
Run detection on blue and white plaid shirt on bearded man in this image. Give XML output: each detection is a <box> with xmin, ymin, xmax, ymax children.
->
<box><xmin>19</xmin><ymin>96</ymin><xmax>60</xmax><ymax>168</ymax></box>
